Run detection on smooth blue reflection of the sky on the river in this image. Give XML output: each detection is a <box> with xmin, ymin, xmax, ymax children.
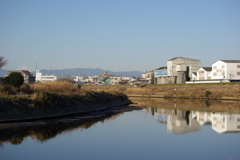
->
<box><xmin>0</xmin><ymin>111</ymin><xmax>240</xmax><ymax>160</ymax></box>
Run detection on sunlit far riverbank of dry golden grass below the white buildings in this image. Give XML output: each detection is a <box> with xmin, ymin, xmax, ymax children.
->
<box><xmin>82</xmin><ymin>83</ymin><xmax>240</xmax><ymax>101</ymax></box>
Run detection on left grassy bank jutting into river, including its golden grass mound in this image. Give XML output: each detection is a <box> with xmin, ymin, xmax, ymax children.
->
<box><xmin>0</xmin><ymin>82</ymin><xmax>130</xmax><ymax>120</ymax></box>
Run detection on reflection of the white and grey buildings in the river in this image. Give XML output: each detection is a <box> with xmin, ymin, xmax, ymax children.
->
<box><xmin>145</xmin><ymin>108</ymin><xmax>240</xmax><ymax>134</ymax></box>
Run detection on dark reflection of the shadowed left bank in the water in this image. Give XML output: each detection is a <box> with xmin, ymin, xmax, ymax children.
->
<box><xmin>0</xmin><ymin>107</ymin><xmax>139</xmax><ymax>144</ymax></box>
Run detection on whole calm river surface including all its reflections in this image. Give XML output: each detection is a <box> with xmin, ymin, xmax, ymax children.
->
<box><xmin>0</xmin><ymin>99</ymin><xmax>240</xmax><ymax>160</ymax></box>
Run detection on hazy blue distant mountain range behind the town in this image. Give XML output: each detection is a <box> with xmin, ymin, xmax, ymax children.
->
<box><xmin>0</xmin><ymin>68</ymin><xmax>144</xmax><ymax>77</ymax></box>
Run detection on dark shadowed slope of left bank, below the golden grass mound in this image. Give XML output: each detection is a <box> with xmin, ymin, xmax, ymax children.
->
<box><xmin>0</xmin><ymin>92</ymin><xmax>131</xmax><ymax>122</ymax></box>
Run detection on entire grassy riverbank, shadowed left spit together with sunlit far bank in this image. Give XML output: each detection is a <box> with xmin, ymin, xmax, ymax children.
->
<box><xmin>0</xmin><ymin>82</ymin><xmax>240</xmax><ymax>119</ymax></box>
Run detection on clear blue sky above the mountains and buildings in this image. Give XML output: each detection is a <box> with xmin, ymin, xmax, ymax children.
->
<box><xmin>0</xmin><ymin>0</ymin><xmax>240</xmax><ymax>71</ymax></box>
